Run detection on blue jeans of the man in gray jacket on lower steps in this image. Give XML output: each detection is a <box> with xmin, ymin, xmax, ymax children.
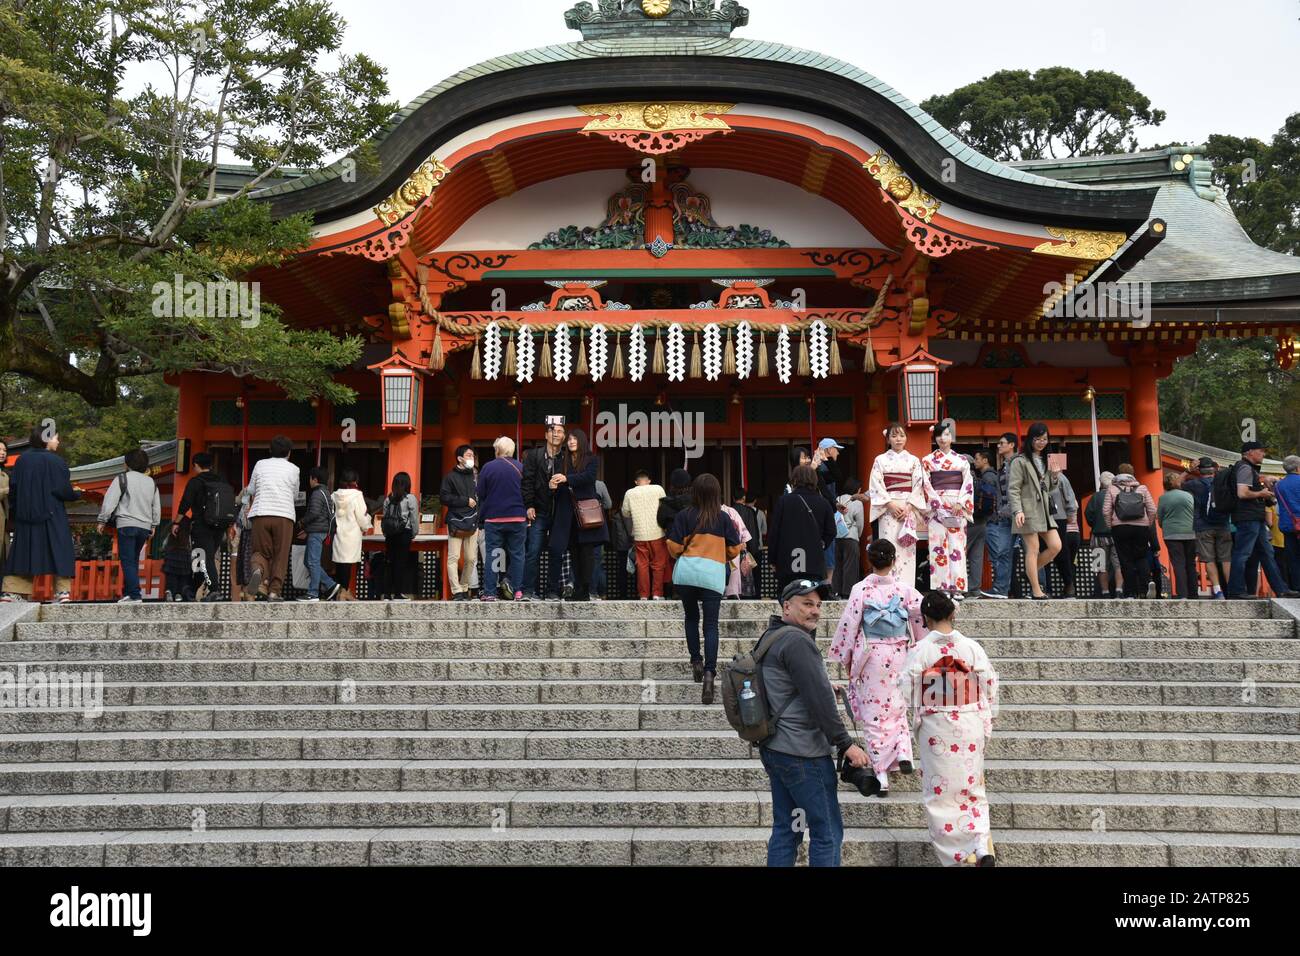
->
<box><xmin>758</xmin><ymin>747</ymin><xmax>844</xmax><ymax>866</ymax></box>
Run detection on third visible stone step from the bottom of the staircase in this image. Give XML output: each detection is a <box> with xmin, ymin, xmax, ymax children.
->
<box><xmin>0</xmin><ymin>758</ymin><xmax>1300</xmax><ymax>796</ymax></box>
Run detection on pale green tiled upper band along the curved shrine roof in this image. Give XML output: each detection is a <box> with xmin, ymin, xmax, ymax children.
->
<box><xmin>250</xmin><ymin>36</ymin><xmax>1087</xmax><ymax>199</ymax></box>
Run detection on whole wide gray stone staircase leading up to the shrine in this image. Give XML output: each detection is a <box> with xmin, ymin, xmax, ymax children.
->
<box><xmin>0</xmin><ymin>601</ymin><xmax>1300</xmax><ymax>866</ymax></box>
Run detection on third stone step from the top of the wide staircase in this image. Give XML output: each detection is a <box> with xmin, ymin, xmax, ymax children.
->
<box><xmin>0</xmin><ymin>628</ymin><xmax>1300</xmax><ymax>667</ymax></box>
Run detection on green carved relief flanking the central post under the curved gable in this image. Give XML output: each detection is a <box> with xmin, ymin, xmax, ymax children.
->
<box><xmin>529</xmin><ymin>168</ymin><xmax>790</xmax><ymax>250</ymax></box>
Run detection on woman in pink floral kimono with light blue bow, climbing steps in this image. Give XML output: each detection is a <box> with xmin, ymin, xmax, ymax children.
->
<box><xmin>831</xmin><ymin>541</ymin><xmax>926</xmax><ymax>796</ymax></box>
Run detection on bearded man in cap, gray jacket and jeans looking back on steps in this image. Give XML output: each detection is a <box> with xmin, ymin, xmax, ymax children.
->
<box><xmin>759</xmin><ymin>579</ymin><xmax>871</xmax><ymax>866</ymax></box>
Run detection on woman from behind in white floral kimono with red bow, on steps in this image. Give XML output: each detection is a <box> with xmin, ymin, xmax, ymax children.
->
<box><xmin>898</xmin><ymin>591</ymin><xmax>997</xmax><ymax>866</ymax></box>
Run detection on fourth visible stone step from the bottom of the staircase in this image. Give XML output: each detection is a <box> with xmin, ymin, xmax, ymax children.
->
<box><xmin>0</xmin><ymin>730</ymin><xmax>1300</xmax><ymax>765</ymax></box>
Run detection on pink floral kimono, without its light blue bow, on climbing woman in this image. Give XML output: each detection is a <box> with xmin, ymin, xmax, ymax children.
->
<box><xmin>831</xmin><ymin>574</ymin><xmax>926</xmax><ymax>774</ymax></box>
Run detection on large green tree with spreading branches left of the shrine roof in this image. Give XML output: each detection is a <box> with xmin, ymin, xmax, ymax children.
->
<box><xmin>0</xmin><ymin>0</ymin><xmax>395</xmax><ymax>408</ymax></box>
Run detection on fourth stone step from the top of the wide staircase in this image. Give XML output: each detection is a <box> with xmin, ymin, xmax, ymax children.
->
<box><xmin>0</xmin><ymin>656</ymin><xmax>1300</xmax><ymax>683</ymax></box>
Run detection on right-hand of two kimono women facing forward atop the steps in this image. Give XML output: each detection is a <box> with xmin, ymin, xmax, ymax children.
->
<box><xmin>920</xmin><ymin>424</ymin><xmax>975</xmax><ymax>601</ymax></box>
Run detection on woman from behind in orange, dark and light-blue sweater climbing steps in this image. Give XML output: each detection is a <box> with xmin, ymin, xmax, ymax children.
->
<box><xmin>668</xmin><ymin>475</ymin><xmax>741</xmax><ymax>704</ymax></box>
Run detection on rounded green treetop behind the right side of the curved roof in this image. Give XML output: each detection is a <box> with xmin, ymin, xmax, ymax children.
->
<box><xmin>920</xmin><ymin>66</ymin><xmax>1165</xmax><ymax>163</ymax></box>
